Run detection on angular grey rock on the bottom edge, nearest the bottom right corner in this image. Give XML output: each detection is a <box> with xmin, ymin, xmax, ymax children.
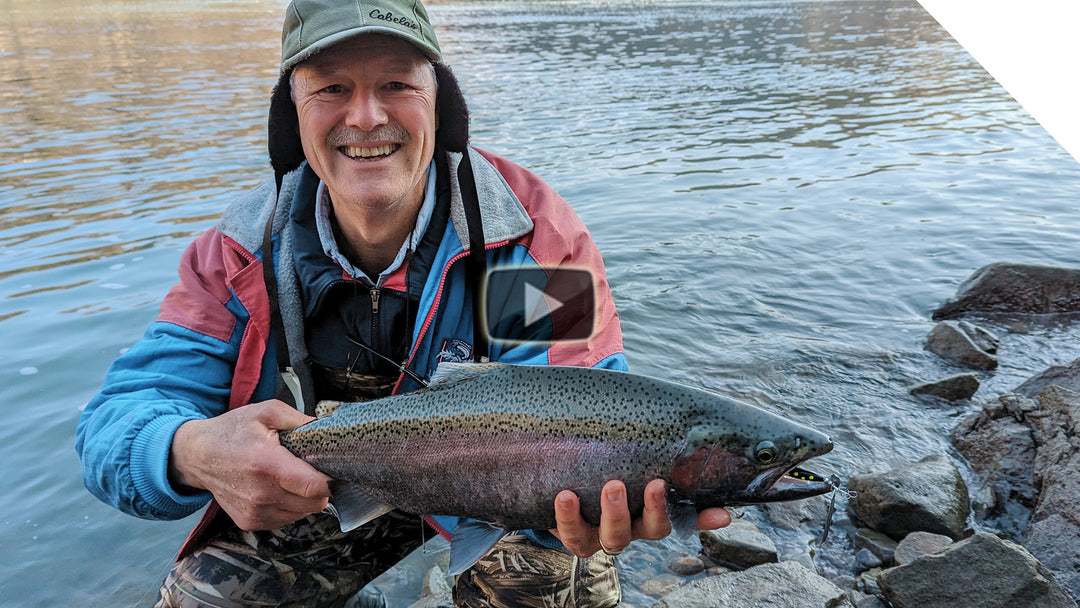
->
<box><xmin>878</xmin><ymin>532</ymin><xmax>1077</xmax><ymax>608</ymax></box>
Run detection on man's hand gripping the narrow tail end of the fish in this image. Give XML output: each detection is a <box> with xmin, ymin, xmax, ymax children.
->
<box><xmin>168</xmin><ymin>401</ymin><xmax>330</xmax><ymax>530</ymax></box>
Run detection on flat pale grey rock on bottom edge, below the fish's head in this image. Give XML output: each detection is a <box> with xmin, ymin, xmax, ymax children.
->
<box><xmin>652</xmin><ymin>562</ymin><xmax>853</xmax><ymax>608</ymax></box>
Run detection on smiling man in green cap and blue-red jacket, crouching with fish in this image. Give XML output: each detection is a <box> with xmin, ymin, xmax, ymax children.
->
<box><xmin>77</xmin><ymin>0</ymin><xmax>728</xmax><ymax>607</ymax></box>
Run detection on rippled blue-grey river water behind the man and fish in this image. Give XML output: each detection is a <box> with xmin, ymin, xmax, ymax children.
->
<box><xmin>0</xmin><ymin>0</ymin><xmax>1080</xmax><ymax>607</ymax></box>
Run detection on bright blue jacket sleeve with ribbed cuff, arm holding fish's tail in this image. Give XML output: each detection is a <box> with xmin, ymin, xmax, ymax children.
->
<box><xmin>76</xmin><ymin>321</ymin><xmax>242</xmax><ymax>519</ymax></box>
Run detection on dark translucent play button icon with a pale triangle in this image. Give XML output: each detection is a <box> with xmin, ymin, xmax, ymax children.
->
<box><xmin>484</xmin><ymin>266</ymin><xmax>596</xmax><ymax>342</ymax></box>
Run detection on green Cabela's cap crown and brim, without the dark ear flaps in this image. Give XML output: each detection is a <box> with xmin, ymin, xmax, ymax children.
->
<box><xmin>281</xmin><ymin>0</ymin><xmax>443</xmax><ymax>73</ymax></box>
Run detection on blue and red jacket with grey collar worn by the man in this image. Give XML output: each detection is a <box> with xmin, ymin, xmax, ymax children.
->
<box><xmin>76</xmin><ymin>150</ymin><xmax>626</xmax><ymax>550</ymax></box>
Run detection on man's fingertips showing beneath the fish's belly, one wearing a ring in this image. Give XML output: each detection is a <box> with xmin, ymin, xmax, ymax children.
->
<box><xmin>551</xmin><ymin>479</ymin><xmax>731</xmax><ymax>557</ymax></box>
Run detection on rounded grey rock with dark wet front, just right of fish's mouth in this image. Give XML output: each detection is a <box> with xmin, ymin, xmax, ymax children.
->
<box><xmin>848</xmin><ymin>456</ymin><xmax>970</xmax><ymax>539</ymax></box>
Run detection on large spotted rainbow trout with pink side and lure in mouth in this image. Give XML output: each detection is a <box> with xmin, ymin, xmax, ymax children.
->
<box><xmin>279</xmin><ymin>363</ymin><xmax>833</xmax><ymax>575</ymax></box>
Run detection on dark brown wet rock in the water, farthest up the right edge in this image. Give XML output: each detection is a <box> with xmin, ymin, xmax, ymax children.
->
<box><xmin>933</xmin><ymin>262</ymin><xmax>1080</xmax><ymax>321</ymax></box>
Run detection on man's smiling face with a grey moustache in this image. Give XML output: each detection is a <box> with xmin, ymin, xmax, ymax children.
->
<box><xmin>292</xmin><ymin>35</ymin><xmax>437</xmax><ymax>215</ymax></box>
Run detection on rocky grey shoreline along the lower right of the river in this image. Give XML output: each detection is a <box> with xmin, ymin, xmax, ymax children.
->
<box><xmin>378</xmin><ymin>264</ymin><xmax>1080</xmax><ymax>608</ymax></box>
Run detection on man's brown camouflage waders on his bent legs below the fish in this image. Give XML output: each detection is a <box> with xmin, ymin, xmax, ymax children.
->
<box><xmin>156</xmin><ymin>511</ymin><xmax>620</xmax><ymax>608</ymax></box>
